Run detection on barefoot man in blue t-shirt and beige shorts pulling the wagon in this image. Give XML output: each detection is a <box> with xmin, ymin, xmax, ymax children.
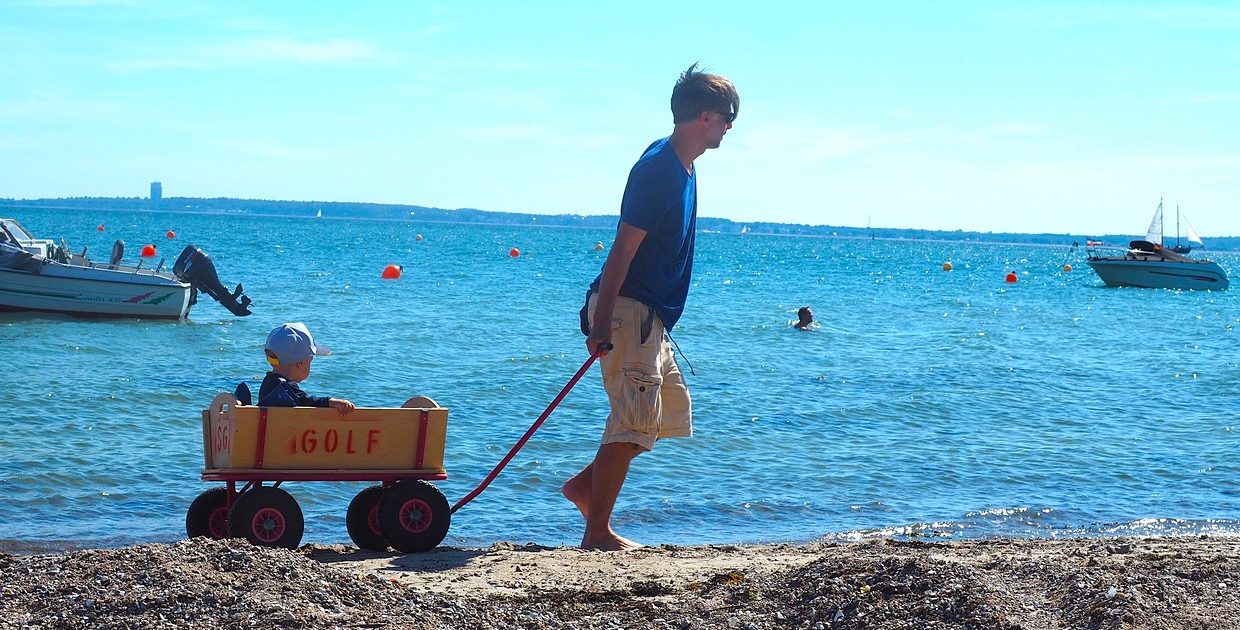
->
<box><xmin>562</xmin><ymin>63</ymin><xmax>740</xmax><ymax>551</ymax></box>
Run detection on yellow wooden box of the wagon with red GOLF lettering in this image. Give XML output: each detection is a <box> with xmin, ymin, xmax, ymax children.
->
<box><xmin>202</xmin><ymin>393</ymin><xmax>448</xmax><ymax>471</ymax></box>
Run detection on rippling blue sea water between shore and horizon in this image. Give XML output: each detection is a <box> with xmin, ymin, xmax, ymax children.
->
<box><xmin>0</xmin><ymin>211</ymin><xmax>1240</xmax><ymax>549</ymax></box>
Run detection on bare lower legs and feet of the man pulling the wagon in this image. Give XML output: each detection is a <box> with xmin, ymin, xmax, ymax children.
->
<box><xmin>560</xmin><ymin>441</ymin><xmax>642</xmax><ymax>551</ymax></box>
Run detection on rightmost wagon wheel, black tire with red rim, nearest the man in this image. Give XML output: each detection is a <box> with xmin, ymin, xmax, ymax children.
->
<box><xmin>379</xmin><ymin>479</ymin><xmax>451</xmax><ymax>553</ymax></box>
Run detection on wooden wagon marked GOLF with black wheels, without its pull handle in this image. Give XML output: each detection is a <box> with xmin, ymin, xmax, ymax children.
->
<box><xmin>185</xmin><ymin>393</ymin><xmax>451</xmax><ymax>553</ymax></box>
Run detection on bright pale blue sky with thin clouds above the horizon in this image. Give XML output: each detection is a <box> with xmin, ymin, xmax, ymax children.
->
<box><xmin>0</xmin><ymin>0</ymin><xmax>1240</xmax><ymax>239</ymax></box>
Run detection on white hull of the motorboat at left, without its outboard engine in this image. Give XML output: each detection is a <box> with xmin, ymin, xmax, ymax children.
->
<box><xmin>0</xmin><ymin>263</ymin><xmax>191</xmax><ymax>319</ymax></box>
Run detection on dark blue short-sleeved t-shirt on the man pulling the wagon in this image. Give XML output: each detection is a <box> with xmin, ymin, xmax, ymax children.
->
<box><xmin>590</xmin><ymin>138</ymin><xmax>697</xmax><ymax>330</ymax></box>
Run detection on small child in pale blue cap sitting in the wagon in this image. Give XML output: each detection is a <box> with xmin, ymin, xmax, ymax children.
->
<box><xmin>258</xmin><ymin>321</ymin><xmax>356</xmax><ymax>413</ymax></box>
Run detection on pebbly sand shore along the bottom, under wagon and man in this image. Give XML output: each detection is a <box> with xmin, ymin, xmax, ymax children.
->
<box><xmin>0</xmin><ymin>537</ymin><xmax>1240</xmax><ymax>630</ymax></box>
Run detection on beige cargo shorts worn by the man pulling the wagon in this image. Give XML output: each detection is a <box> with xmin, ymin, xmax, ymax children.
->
<box><xmin>588</xmin><ymin>295</ymin><xmax>693</xmax><ymax>450</ymax></box>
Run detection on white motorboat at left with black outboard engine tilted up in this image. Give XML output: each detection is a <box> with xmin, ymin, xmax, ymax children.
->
<box><xmin>0</xmin><ymin>218</ymin><xmax>250</xmax><ymax>319</ymax></box>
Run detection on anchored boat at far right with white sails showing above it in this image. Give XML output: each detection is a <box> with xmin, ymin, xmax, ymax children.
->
<box><xmin>1085</xmin><ymin>200</ymin><xmax>1230</xmax><ymax>290</ymax></box>
